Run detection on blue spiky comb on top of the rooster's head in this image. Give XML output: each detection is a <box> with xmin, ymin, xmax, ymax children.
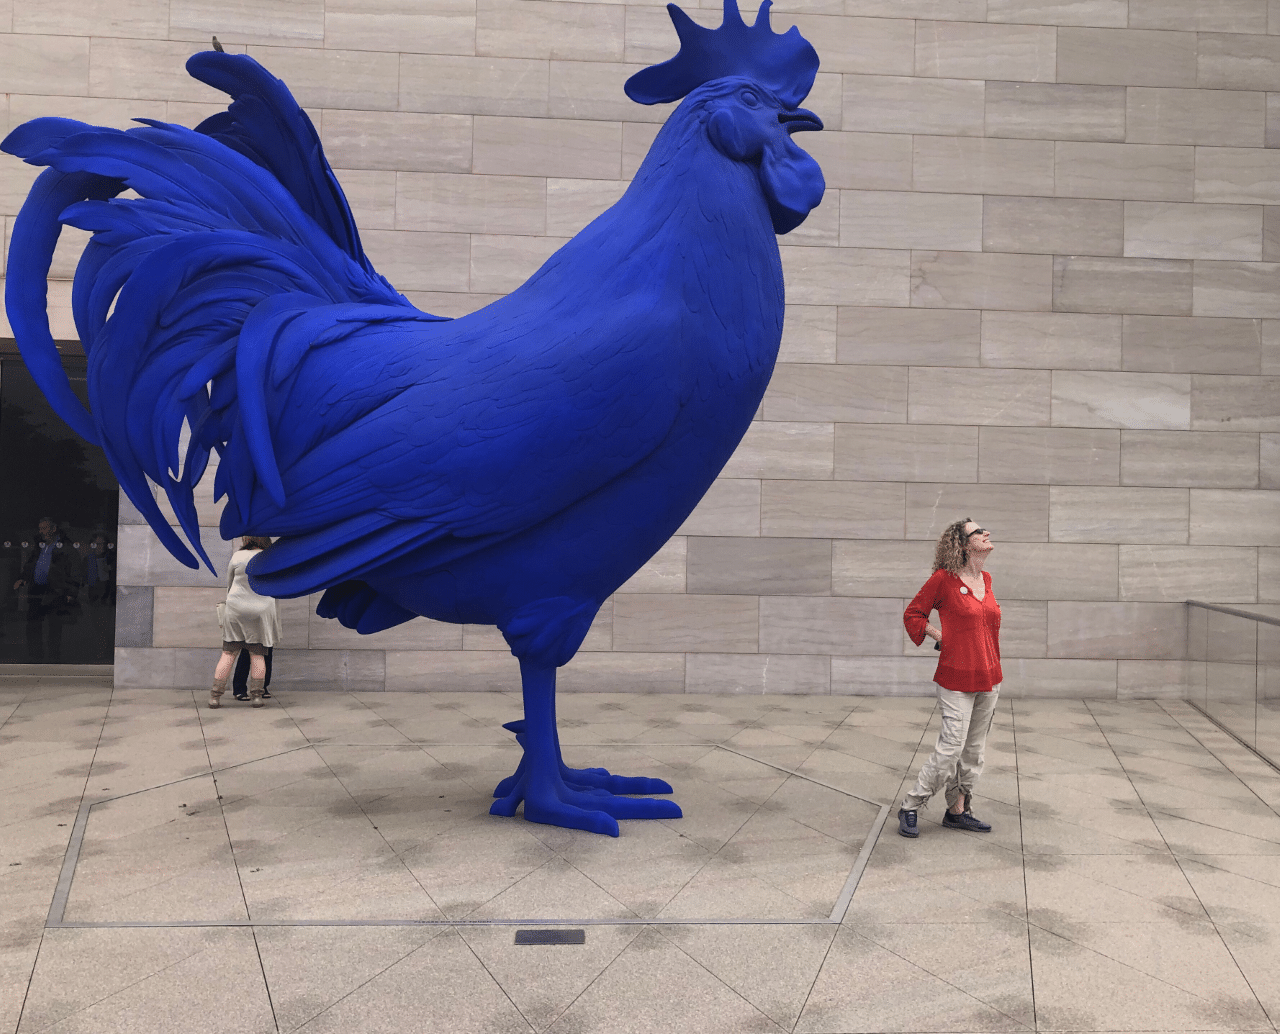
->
<box><xmin>623</xmin><ymin>0</ymin><xmax>818</xmax><ymax>107</ymax></box>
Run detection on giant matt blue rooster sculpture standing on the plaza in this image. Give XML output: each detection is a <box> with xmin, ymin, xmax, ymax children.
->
<box><xmin>0</xmin><ymin>0</ymin><xmax>824</xmax><ymax>836</ymax></box>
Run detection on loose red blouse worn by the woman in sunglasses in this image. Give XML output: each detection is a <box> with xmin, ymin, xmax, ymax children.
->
<box><xmin>902</xmin><ymin>569</ymin><xmax>1004</xmax><ymax>692</ymax></box>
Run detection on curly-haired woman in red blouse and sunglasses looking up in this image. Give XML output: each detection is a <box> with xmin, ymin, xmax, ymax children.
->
<box><xmin>897</xmin><ymin>518</ymin><xmax>1004</xmax><ymax>837</ymax></box>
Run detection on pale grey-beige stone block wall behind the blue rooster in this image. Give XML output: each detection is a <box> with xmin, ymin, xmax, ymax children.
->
<box><xmin>0</xmin><ymin>0</ymin><xmax>1280</xmax><ymax>697</ymax></box>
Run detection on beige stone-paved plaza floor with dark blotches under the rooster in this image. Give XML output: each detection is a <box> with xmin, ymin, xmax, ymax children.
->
<box><xmin>0</xmin><ymin>676</ymin><xmax>1280</xmax><ymax>1034</ymax></box>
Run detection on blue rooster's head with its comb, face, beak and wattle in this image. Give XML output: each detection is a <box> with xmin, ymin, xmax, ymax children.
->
<box><xmin>625</xmin><ymin>0</ymin><xmax>826</xmax><ymax>234</ymax></box>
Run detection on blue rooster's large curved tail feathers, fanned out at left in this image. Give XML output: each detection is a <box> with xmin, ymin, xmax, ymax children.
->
<box><xmin>0</xmin><ymin>52</ymin><xmax>422</xmax><ymax>573</ymax></box>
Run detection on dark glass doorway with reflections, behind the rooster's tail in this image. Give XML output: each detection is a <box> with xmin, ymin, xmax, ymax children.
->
<box><xmin>0</xmin><ymin>357</ymin><xmax>119</xmax><ymax>664</ymax></box>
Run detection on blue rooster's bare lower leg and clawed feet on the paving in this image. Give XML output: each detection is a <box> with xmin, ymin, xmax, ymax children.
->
<box><xmin>489</xmin><ymin>660</ymin><xmax>681</xmax><ymax>837</ymax></box>
